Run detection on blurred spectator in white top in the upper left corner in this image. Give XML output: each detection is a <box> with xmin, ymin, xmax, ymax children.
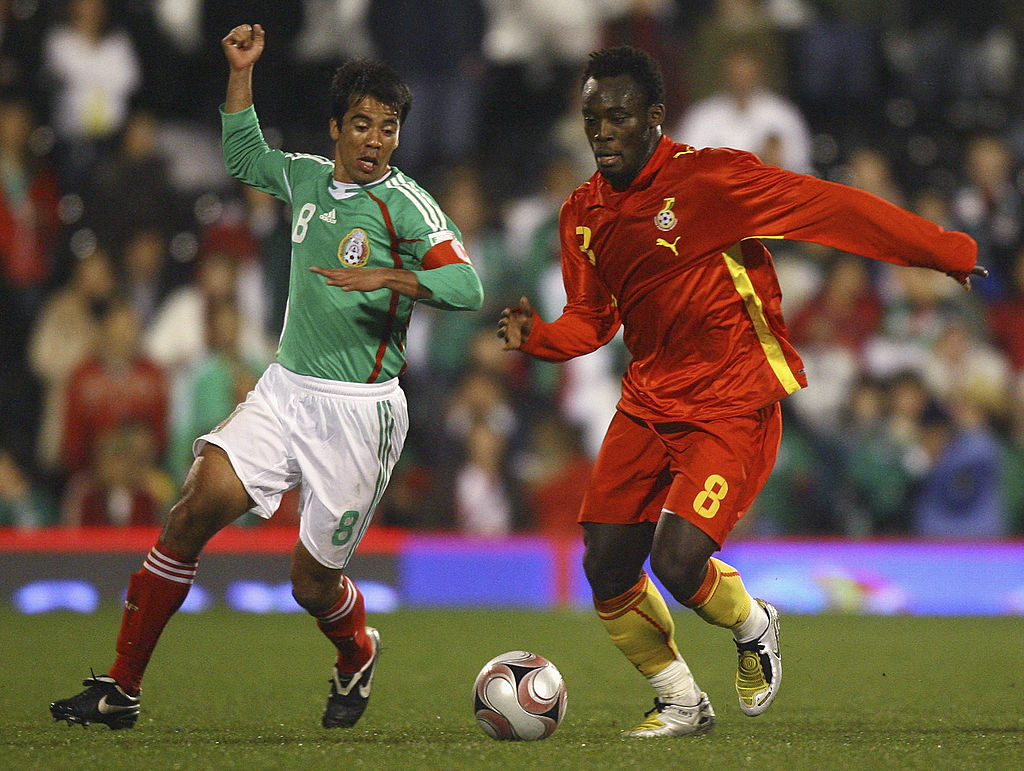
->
<box><xmin>42</xmin><ymin>0</ymin><xmax>141</xmax><ymax>189</ymax></box>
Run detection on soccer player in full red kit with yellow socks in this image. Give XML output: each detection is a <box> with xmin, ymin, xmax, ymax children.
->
<box><xmin>499</xmin><ymin>47</ymin><xmax>985</xmax><ymax>737</ymax></box>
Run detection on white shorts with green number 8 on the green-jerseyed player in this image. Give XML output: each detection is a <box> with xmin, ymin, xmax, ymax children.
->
<box><xmin>193</xmin><ymin>363</ymin><xmax>409</xmax><ymax>568</ymax></box>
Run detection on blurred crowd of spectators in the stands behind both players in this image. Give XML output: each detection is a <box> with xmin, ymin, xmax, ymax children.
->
<box><xmin>0</xmin><ymin>0</ymin><xmax>1024</xmax><ymax>539</ymax></box>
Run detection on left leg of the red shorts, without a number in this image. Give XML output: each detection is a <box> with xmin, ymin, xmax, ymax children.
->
<box><xmin>580</xmin><ymin>412</ymin><xmax>672</xmax><ymax>524</ymax></box>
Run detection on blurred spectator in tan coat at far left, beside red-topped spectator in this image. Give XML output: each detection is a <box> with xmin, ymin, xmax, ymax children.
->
<box><xmin>29</xmin><ymin>251</ymin><xmax>116</xmax><ymax>477</ymax></box>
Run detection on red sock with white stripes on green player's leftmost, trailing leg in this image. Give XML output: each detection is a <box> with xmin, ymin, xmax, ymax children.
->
<box><xmin>109</xmin><ymin>544</ymin><xmax>199</xmax><ymax>695</ymax></box>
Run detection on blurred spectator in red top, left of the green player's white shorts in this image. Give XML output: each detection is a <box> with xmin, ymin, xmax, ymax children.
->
<box><xmin>60</xmin><ymin>299</ymin><xmax>170</xmax><ymax>473</ymax></box>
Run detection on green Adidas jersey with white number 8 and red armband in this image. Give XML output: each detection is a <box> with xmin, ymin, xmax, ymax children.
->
<box><xmin>221</xmin><ymin>106</ymin><xmax>483</xmax><ymax>383</ymax></box>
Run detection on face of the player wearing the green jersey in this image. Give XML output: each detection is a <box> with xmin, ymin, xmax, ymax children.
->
<box><xmin>331</xmin><ymin>96</ymin><xmax>398</xmax><ymax>184</ymax></box>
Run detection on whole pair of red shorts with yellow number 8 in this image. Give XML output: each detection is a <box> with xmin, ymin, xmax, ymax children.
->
<box><xmin>580</xmin><ymin>402</ymin><xmax>782</xmax><ymax>546</ymax></box>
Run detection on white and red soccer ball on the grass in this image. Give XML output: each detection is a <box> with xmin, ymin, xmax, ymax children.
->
<box><xmin>473</xmin><ymin>650</ymin><xmax>566</xmax><ymax>741</ymax></box>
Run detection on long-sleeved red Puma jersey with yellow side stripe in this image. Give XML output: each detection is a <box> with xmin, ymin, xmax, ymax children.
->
<box><xmin>522</xmin><ymin>136</ymin><xmax>977</xmax><ymax>422</ymax></box>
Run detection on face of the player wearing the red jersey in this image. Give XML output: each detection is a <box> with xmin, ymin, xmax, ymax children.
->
<box><xmin>583</xmin><ymin>75</ymin><xmax>665</xmax><ymax>189</ymax></box>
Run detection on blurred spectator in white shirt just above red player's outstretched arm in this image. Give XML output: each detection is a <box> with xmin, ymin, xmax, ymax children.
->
<box><xmin>673</xmin><ymin>48</ymin><xmax>811</xmax><ymax>174</ymax></box>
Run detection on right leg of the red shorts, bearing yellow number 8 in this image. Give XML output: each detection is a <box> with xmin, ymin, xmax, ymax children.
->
<box><xmin>665</xmin><ymin>403</ymin><xmax>782</xmax><ymax>545</ymax></box>
